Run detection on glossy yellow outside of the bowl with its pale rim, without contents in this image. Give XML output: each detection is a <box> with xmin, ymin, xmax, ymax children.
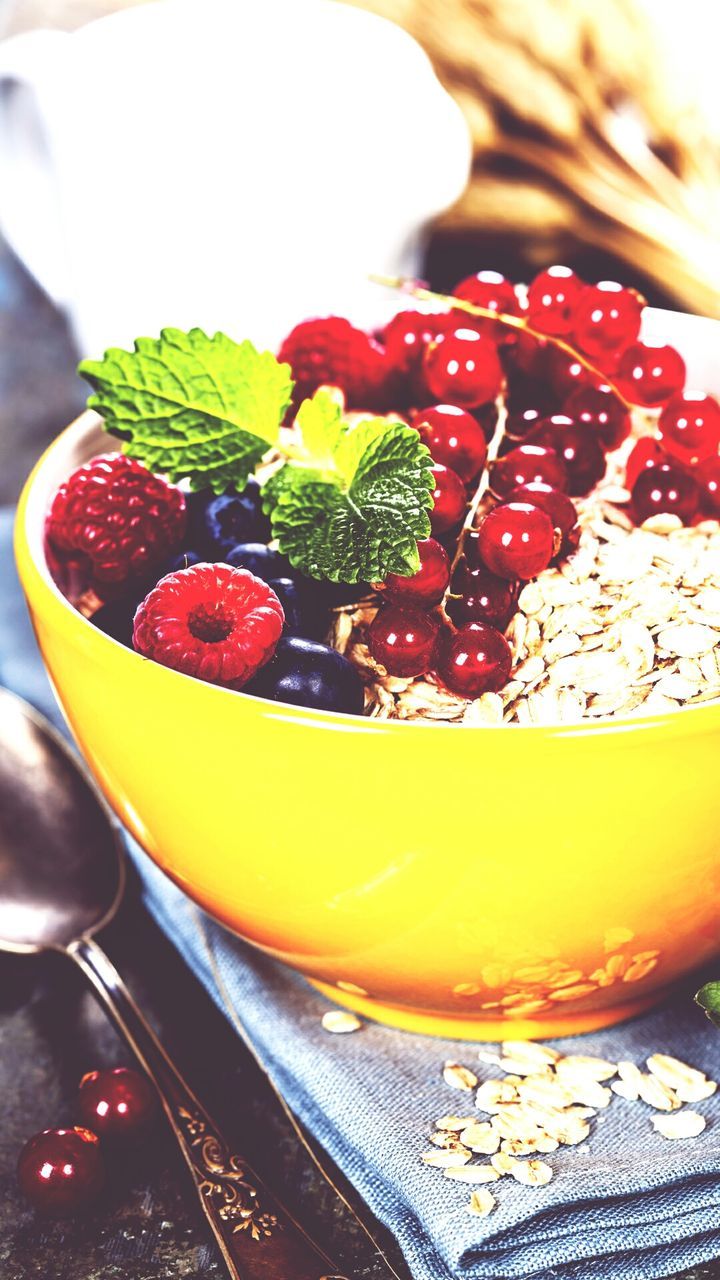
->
<box><xmin>9</xmin><ymin>415</ymin><xmax>720</xmax><ymax>1038</ymax></box>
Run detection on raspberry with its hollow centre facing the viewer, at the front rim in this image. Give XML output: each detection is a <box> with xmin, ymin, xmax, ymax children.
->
<box><xmin>132</xmin><ymin>564</ymin><xmax>284</xmax><ymax>689</ymax></box>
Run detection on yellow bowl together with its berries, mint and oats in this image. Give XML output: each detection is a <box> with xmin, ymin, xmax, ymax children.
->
<box><xmin>17</xmin><ymin>275</ymin><xmax>720</xmax><ymax>1037</ymax></box>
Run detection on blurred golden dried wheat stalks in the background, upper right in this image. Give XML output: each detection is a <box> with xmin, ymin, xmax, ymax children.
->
<box><xmin>355</xmin><ymin>0</ymin><xmax>720</xmax><ymax>315</ymax></box>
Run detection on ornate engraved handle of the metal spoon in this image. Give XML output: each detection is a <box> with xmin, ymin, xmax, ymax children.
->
<box><xmin>68</xmin><ymin>937</ymin><xmax>347</xmax><ymax>1280</ymax></box>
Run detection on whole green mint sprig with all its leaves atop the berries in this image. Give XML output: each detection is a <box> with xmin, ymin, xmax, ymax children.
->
<box><xmin>78</xmin><ymin>329</ymin><xmax>434</xmax><ymax>582</ymax></box>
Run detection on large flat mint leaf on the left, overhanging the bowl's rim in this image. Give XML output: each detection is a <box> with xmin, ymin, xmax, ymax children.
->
<box><xmin>78</xmin><ymin>329</ymin><xmax>292</xmax><ymax>493</ymax></box>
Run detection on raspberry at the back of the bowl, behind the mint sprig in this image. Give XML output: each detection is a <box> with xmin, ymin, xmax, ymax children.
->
<box><xmin>278</xmin><ymin>316</ymin><xmax>392</xmax><ymax>410</ymax></box>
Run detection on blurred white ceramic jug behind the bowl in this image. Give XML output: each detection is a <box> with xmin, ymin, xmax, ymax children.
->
<box><xmin>0</xmin><ymin>0</ymin><xmax>470</xmax><ymax>353</ymax></box>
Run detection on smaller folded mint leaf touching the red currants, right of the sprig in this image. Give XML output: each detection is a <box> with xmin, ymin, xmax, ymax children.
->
<box><xmin>265</xmin><ymin>419</ymin><xmax>434</xmax><ymax>582</ymax></box>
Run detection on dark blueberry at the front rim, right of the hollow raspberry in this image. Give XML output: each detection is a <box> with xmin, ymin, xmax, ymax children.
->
<box><xmin>245</xmin><ymin>636</ymin><xmax>365</xmax><ymax>716</ymax></box>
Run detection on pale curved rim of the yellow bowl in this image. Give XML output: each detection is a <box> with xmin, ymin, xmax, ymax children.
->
<box><xmin>14</xmin><ymin>410</ymin><xmax>720</xmax><ymax>739</ymax></box>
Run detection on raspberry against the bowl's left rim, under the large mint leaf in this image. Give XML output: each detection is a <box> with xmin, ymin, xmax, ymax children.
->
<box><xmin>46</xmin><ymin>453</ymin><xmax>186</xmax><ymax>582</ymax></box>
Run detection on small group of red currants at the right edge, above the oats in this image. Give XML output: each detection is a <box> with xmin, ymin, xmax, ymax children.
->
<box><xmin>625</xmin><ymin>392</ymin><xmax>720</xmax><ymax>525</ymax></box>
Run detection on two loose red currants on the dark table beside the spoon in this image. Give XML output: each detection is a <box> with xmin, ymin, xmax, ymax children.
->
<box><xmin>18</xmin><ymin>1066</ymin><xmax>158</xmax><ymax>1215</ymax></box>
